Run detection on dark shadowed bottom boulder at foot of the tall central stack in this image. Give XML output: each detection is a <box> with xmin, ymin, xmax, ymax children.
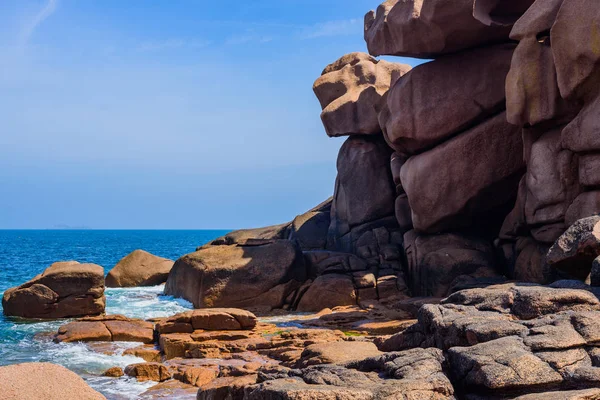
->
<box><xmin>404</xmin><ymin>231</ymin><xmax>497</xmax><ymax>297</ymax></box>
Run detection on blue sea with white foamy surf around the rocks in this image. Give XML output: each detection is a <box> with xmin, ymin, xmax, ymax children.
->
<box><xmin>0</xmin><ymin>230</ymin><xmax>228</xmax><ymax>400</ymax></box>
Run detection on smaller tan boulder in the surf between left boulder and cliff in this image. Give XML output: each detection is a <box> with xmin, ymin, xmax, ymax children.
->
<box><xmin>106</xmin><ymin>250</ymin><xmax>173</xmax><ymax>287</ymax></box>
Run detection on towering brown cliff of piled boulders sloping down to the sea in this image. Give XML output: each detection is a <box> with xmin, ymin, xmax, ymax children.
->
<box><xmin>167</xmin><ymin>0</ymin><xmax>600</xmax><ymax>311</ymax></box>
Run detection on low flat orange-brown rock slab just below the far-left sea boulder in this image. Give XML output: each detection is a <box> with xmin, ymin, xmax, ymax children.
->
<box><xmin>54</xmin><ymin>315</ymin><xmax>154</xmax><ymax>343</ymax></box>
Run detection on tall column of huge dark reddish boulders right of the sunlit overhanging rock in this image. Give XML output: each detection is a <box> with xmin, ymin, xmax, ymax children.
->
<box><xmin>365</xmin><ymin>0</ymin><xmax>524</xmax><ymax>296</ymax></box>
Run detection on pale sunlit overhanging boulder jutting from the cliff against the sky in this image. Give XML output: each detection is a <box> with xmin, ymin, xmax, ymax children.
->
<box><xmin>313</xmin><ymin>53</ymin><xmax>411</xmax><ymax>136</ymax></box>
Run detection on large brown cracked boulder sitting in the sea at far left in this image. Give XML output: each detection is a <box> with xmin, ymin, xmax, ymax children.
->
<box><xmin>2</xmin><ymin>261</ymin><xmax>106</xmax><ymax>318</ymax></box>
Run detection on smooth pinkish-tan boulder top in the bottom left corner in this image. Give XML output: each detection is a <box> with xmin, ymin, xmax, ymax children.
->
<box><xmin>0</xmin><ymin>363</ymin><xmax>106</xmax><ymax>400</ymax></box>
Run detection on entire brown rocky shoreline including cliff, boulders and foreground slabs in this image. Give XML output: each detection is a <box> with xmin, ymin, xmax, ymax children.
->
<box><xmin>5</xmin><ymin>0</ymin><xmax>600</xmax><ymax>400</ymax></box>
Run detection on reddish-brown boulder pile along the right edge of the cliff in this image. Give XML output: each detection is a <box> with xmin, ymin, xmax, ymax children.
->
<box><xmin>487</xmin><ymin>0</ymin><xmax>600</xmax><ymax>282</ymax></box>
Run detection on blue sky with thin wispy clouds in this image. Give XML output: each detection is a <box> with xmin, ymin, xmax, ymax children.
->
<box><xmin>0</xmin><ymin>0</ymin><xmax>422</xmax><ymax>229</ymax></box>
